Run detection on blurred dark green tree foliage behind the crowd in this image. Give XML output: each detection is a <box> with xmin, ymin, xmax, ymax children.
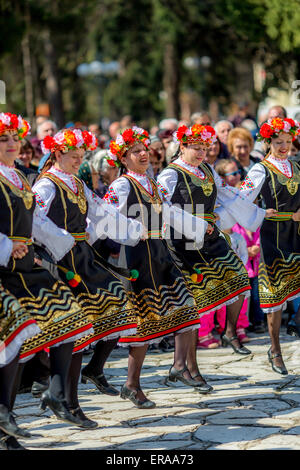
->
<box><xmin>0</xmin><ymin>0</ymin><xmax>300</xmax><ymax>124</ymax></box>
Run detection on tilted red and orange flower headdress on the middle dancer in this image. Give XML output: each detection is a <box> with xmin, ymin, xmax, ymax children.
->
<box><xmin>106</xmin><ymin>126</ymin><xmax>150</xmax><ymax>166</ymax></box>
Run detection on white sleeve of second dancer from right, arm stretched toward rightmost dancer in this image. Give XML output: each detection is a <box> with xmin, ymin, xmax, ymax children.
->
<box><xmin>211</xmin><ymin>167</ymin><xmax>266</xmax><ymax>232</ymax></box>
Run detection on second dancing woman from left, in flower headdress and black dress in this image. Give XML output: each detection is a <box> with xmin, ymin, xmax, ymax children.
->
<box><xmin>33</xmin><ymin>129</ymin><xmax>144</xmax><ymax>427</ymax></box>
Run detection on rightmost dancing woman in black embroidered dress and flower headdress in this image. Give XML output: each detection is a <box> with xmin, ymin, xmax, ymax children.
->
<box><xmin>240</xmin><ymin>118</ymin><xmax>300</xmax><ymax>375</ymax></box>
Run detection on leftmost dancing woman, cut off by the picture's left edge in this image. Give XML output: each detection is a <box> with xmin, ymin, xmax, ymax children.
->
<box><xmin>0</xmin><ymin>113</ymin><xmax>92</xmax><ymax>448</ymax></box>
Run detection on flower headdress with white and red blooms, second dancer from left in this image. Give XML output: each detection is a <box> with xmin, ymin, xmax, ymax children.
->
<box><xmin>41</xmin><ymin>129</ymin><xmax>98</xmax><ymax>154</ymax></box>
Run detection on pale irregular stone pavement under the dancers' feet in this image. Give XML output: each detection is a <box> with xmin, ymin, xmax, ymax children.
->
<box><xmin>8</xmin><ymin>328</ymin><xmax>300</xmax><ymax>451</ymax></box>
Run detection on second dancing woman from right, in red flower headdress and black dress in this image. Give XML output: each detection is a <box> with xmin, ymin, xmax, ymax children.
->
<box><xmin>158</xmin><ymin>125</ymin><xmax>276</xmax><ymax>383</ymax></box>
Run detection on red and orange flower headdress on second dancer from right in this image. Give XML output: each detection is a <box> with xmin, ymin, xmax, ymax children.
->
<box><xmin>173</xmin><ymin>124</ymin><xmax>217</xmax><ymax>146</ymax></box>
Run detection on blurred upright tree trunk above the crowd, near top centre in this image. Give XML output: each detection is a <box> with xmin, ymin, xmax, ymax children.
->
<box><xmin>163</xmin><ymin>43</ymin><xmax>180</xmax><ymax>119</ymax></box>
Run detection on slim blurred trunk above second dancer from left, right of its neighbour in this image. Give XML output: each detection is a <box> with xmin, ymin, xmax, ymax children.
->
<box><xmin>43</xmin><ymin>29</ymin><xmax>65</xmax><ymax>128</ymax></box>
